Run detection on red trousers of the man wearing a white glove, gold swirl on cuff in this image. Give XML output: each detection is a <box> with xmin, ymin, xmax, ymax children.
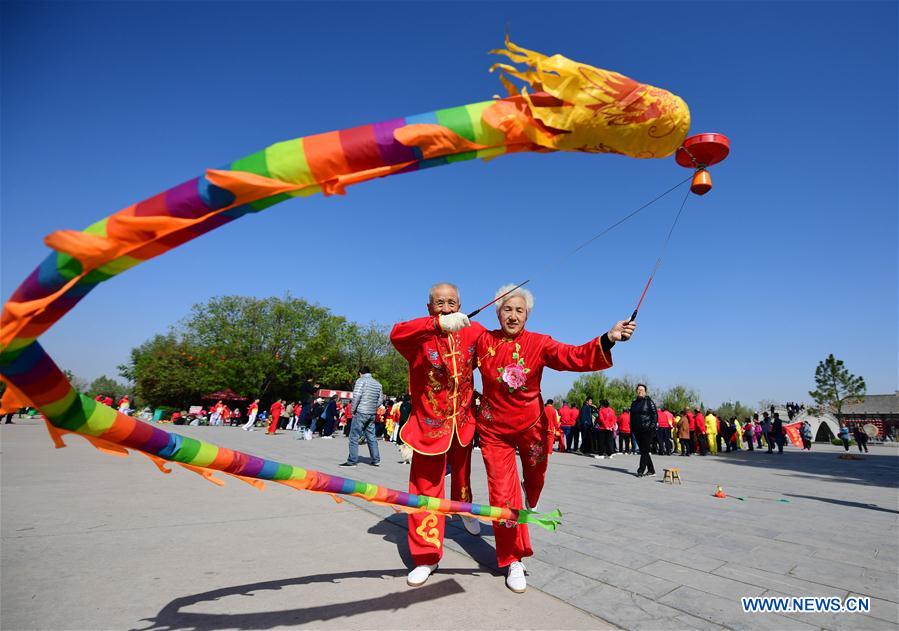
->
<box><xmin>409</xmin><ymin>436</ymin><xmax>472</xmax><ymax>565</ymax></box>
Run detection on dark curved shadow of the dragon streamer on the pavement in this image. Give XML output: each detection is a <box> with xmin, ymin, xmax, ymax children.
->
<box><xmin>134</xmin><ymin>568</ymin><xmax>481</xmax><ymax>631</ymax></box>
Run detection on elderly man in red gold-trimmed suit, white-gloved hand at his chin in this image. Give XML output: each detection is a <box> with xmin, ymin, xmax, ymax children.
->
<box><xmin>390</xmin><ymin>283</ymin><xmax>484</xmax><ymax>587</ymax></box>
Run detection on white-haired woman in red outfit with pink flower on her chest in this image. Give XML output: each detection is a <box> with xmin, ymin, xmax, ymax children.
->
<box><xmin>477</xmin><ymin>285</ymin><xmax>636</xmax><ymax>593</ymax></box>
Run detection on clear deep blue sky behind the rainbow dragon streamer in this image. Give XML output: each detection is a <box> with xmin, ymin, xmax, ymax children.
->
<box><xmin>0</xmin><ymin>1</ymin><xmax>899</xmax><ymax>405</ymax></box>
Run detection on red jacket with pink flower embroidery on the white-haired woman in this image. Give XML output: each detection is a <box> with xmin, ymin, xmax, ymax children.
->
<box><xmin>477</xmin><ymin>330</ymin><xmax>612</xmax><ymax>434</ymax></box>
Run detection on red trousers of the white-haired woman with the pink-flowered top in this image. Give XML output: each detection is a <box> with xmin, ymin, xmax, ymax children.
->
<box><xmin>480</xmin><ymin>420</ymin><xmax>552</xmax><ymax>567</ymax></box>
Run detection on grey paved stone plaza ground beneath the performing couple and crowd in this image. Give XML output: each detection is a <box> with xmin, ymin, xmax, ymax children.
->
<box><xmin>0</xmin><ymin>420</ymin><xmax>899</xmax><ymax>631</ymax></box>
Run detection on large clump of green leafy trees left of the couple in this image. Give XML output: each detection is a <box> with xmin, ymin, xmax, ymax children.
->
<box><xmin>120</xmin><ymin>295</ymin><xmax>408</xmax><ymax>407</ymax></box>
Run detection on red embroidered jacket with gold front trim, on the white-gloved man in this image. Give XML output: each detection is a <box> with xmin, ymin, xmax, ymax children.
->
<box><xmin>390</xmin><ymin>316</ymin><xmax>485</xmax><ymax>456</ymax></box>
